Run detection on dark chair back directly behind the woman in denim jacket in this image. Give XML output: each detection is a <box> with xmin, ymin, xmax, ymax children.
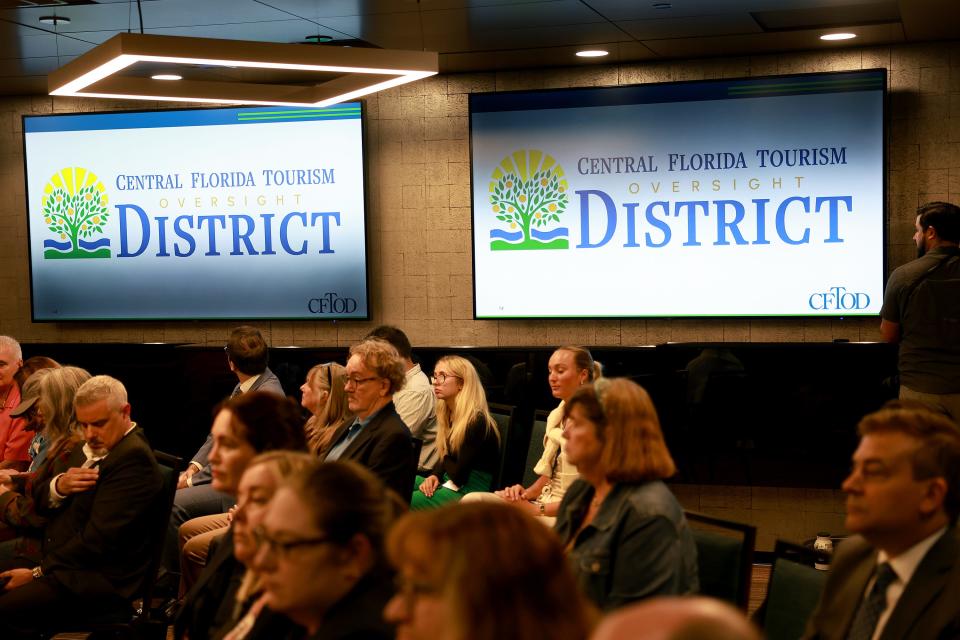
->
<box><xmin>685</xmin><ymin>511</ymin><xmax>757</xmax><ymax>611</ymax></box>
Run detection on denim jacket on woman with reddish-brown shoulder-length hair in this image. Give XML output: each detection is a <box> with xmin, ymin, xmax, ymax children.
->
<box><xmin>556</xmin><ymin>480</ymin><xmax>700</xmax><ymax>610</ymax></box>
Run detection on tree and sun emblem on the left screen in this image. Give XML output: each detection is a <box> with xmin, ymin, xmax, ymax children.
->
<box><xmin>40</xmin><ymin>167</ymin><xmax>110</xmax><ymax>260</ymax></box>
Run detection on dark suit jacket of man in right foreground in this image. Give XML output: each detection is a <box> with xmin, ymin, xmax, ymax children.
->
<box><xmin>803</xmin><ymin>527</ymin><xmax>960</xmax><ymax>640</ymax></box>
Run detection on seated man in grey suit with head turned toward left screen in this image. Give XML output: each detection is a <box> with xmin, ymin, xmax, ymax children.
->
<box><xmin>162</xmin><ymin>325</ymin><xmax>286</xmax><ymax>583</ymax></box>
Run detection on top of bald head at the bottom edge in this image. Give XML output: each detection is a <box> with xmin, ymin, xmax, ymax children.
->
<box><xmin>590</xmin><ymin>596</ymin><xmax>761</xmax><ymax>640</ymax></box>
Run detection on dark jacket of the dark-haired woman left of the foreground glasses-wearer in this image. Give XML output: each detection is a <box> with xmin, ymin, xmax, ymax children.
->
<box><xmin>174</xmin><ymin>527</ymin><xmax>246</xmax><ymax>640</ymax></box>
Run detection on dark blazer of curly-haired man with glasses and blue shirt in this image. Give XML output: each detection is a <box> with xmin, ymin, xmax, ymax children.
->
<box><xmin>328</xmin><ymin>402</ymin><xmax>419</xmax><ymax>497</ymax></box>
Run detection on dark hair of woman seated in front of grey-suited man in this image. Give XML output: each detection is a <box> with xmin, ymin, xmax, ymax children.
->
<box><xmin>221</xmin><ymin>391</ymin><xmax>307</xmax><ymax>453</ymax></box>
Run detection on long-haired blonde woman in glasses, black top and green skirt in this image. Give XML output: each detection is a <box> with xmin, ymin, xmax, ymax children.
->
<box><xmin>410</xmin><ymin>356</ymin><xmax>500</xmax><ymax>510</ymax></box>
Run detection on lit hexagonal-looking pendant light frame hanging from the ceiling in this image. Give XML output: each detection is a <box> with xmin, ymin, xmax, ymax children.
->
<box><xmin>47</xmin><ymin>33</ymin><xmax>438</xmax><ymax>107</ymax></box>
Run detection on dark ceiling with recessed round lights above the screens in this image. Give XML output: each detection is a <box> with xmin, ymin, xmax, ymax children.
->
<box><xmin>0</xmin><ymin>0</ymin><xmax>960</xmax><ymax>95</ymax></box>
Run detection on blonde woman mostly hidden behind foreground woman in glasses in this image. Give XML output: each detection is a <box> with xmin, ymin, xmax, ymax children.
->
<box><xmin>210</xmin><ymin>451</ymin><xmax>317</xmax><ymax>640</ymax></box>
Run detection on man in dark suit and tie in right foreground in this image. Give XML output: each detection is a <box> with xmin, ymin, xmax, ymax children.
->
<box><xmin>804</xmin><ymin>401</ymin><xmax>960</xmax><ymax>640</ymax></box>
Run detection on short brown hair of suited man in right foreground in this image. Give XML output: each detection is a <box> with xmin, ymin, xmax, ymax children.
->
<box><xmin>857</xmin><ymin>408</ymin><xmax>960</xmax><ymax>522</ymax></box>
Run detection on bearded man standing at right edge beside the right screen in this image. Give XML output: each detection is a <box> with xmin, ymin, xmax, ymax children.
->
<box><xmin>880</xmin><ymin>202</ymin><xmax>960</xmax><ymax>422</ymax></box>
